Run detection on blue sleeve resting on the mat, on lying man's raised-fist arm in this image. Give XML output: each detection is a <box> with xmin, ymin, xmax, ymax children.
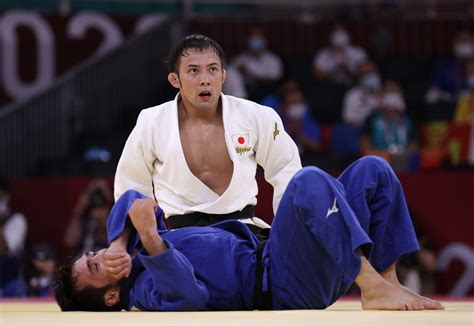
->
<box><xmin>130</xmin><ymin>240</ymin><xmax>209</xmax><ymax>311</ymax></box>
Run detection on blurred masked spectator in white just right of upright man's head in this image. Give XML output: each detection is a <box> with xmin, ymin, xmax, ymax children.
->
<box><xmin>231</xmin><ymin>28</ymin><xmax>283</xmax><ymax>101</ymax></box>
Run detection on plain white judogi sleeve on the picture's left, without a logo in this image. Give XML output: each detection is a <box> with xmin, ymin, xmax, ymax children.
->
<box><xmin>114</xmin><ymin>110</ymin><xmax>157</xmax><ymax>201</ymax></box>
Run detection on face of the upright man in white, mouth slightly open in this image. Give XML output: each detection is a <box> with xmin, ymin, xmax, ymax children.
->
<box><xmin>168</xmin><ymin>49</ymin><xmax>226</xmax><ymax>110</ymax></box>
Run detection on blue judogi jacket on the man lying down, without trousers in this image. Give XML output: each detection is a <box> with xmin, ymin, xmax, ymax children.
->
<box><xmin>107</xmin><ymin>190</ymin><xmax>258</xmax><ymax>311</ymax></box>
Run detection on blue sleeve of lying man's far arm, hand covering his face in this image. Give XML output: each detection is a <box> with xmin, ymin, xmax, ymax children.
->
<box><xmin>107</xmin><ymin>190</ymin><xmax>166</xmax><ymax>253</ymax></box>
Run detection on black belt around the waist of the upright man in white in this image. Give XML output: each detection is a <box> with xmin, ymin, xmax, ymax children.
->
<box><xmin>168</xmin><ymin>205</ymin><xmax>255</xmax><ymax>229</ymax></box>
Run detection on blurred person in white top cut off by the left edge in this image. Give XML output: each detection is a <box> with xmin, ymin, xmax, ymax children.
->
<box><xmin>0</xmin><ymin>178</ymin><xmax>28</xmax><ymax>296</ymax></box>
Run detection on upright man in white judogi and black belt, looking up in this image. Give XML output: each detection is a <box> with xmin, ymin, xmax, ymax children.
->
<box><xmin>114</xmin><ymin>35</ymin><xmax>301</xmax><ymax>228</ymax></box>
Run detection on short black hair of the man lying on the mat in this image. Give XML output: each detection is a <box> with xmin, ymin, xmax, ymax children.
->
<box><xmin>53</xmin><ymin>257</ymin><xmax>121</xmax><ymax>311</ymax></box>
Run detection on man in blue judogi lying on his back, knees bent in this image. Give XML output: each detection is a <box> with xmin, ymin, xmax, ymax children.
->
<box><xmin>55</xmin><ymin>157</ymin><xmax>443</xmax><ymax>311</ymax></box>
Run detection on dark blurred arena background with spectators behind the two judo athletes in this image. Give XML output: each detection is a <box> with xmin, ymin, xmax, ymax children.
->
<box><xmin>0</xmin><ymin>0</ymin><xmax>474</xmax><ymax>297</ymax></box>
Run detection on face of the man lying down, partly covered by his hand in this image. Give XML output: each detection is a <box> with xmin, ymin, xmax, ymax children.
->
<box><xmin>74</xmin><ymin>249</ymin><xmax>117</xmax><ymax>288</ymax></box>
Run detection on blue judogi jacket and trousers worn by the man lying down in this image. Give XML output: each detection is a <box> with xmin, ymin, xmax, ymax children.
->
<box><xmin>108</xmin><ymin>157</ymin><xmax>419</xmax><ymax>310</ymax></box>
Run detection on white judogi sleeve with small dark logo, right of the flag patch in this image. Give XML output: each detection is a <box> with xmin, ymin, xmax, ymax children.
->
<box><xmin>255</xmin><ymin>107</ymin><xmax>301</xmax><ymax>214</ymax></box>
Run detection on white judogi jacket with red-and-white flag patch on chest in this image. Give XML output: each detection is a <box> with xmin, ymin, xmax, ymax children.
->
<box><xmin>114</xmin><ymin>94</ymin><xmax>301</xmax><ymax>217</ymax></box>
